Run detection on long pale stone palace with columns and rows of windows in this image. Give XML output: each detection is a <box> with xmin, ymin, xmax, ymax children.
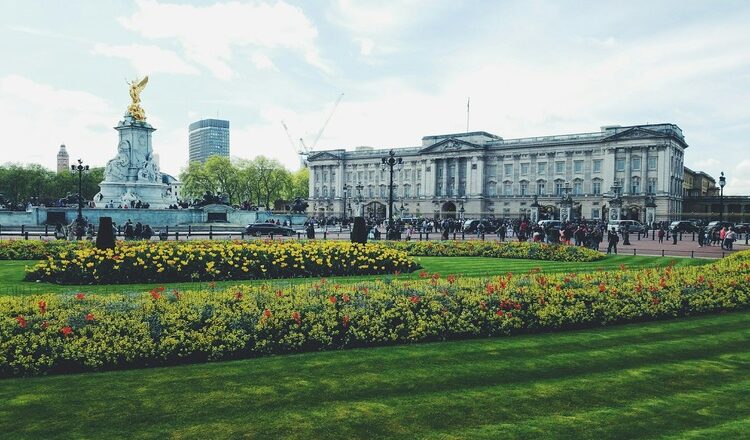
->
<box><xmin>307</xmin><ymin>124</ymin><xmax>687</xmax><ymax>223</ymax></box>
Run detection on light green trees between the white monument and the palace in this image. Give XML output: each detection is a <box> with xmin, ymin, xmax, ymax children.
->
<box><xmin>180</xmin><ymin>156</ymin><xmax>309</xmax><ymax>209</ymax></box>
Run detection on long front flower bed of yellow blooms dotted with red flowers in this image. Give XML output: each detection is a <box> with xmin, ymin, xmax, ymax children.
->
<box><xmin>0</xmin><ymin>252</ymin><xmax>750</xmax><ymax>376</ymax></box>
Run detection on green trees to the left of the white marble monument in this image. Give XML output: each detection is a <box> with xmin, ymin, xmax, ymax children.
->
<box><xmin>0</xmin><ymin>164</ymin><xmax>104</xmax><ymax>205</ymax></box>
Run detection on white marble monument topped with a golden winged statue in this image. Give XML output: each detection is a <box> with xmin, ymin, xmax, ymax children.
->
<box><xmin>94</xmin><ymin>77</ymin><xmax>177</xmax><ymax>208</ymax></box>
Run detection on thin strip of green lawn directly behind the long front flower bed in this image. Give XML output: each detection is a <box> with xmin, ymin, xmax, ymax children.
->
<box><xmin>0</xmin><ymin>255</ymin><xmax>715</xmax><ymax>295</ymax></box>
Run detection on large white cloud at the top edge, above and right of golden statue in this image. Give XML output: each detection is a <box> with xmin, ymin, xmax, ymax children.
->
<box><xmin>118</xmin><ymin>0</ymin><xmax>330</xmax><ymax>80</ymax></box>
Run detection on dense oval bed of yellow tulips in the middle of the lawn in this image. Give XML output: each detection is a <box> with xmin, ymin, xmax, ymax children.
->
<box><xmin>26</xmin><ymin>241</ymin><xmax>419</xmax><ymax>284</ymax></box>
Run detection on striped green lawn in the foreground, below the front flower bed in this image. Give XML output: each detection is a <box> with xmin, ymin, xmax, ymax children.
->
<box><xmin>0</xmin><ymin>312</ymin><xmax>750</xmax><ymax>439</ymax></box>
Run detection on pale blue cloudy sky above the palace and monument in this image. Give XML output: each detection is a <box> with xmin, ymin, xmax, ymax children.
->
<box><xmin>0</xmin><ymin>0</ymin><xmax>750</xmax><ymax>194</ymax></box>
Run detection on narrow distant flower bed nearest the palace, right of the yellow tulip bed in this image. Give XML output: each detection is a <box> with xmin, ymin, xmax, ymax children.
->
<box><xmin>386</xmin><ymin>240</ymin><xmax>604</xmax><ymax>262</ymax></box>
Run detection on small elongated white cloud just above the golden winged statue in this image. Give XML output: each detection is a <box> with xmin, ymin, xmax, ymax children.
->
<box><xmin>92</xmin><ymin>43</ymin><xmax>199</xmax><ymax>75</ymax></box>
